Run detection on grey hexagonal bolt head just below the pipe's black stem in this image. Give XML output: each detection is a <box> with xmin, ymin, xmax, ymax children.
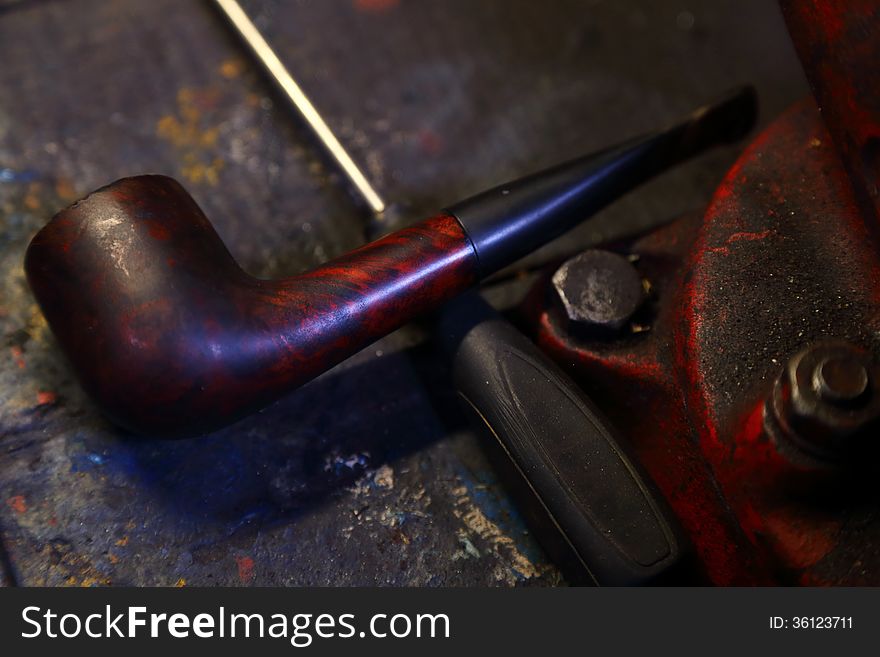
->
<box><xmin>553</xmin><ymin>249</ymin><xmax>645</xmax><ymax>336</ymax></box>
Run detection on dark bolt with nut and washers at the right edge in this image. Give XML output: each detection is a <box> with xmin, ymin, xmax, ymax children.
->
<box><xmin>767</xmin><ymin>341</ymin><xmax>880</xmax><ymax>461</ymax></box>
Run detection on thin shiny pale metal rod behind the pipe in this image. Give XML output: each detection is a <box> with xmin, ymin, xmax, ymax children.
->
<box><xmin>214</xmin><ymin>0</ymin><xmax>386</xmax><ymax>215</ymax></box>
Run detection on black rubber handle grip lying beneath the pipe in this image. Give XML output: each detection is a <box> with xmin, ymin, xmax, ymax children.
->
<box><xmin>440</xmin><ymin>294</ymin><xmax>683</xmax><ymax>585</ymax></box>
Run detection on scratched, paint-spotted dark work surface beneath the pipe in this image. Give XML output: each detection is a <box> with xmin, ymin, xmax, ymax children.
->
<box><xmin>0</xmin><ymin>0</ymin><xmax>805</xmax><ymax>586</ymax></box>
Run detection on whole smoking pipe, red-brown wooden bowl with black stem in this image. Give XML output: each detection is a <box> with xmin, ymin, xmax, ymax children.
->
<box><xmin>25</xmin><ymin>88</ymin><xmax>755</xmax><ymax>437</ymax></box>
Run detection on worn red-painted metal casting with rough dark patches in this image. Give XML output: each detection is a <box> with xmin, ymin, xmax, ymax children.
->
<box><xmin>536</xmin><ymin>1</ymin><xmax>880</xmax><ymax>585</ymax></box>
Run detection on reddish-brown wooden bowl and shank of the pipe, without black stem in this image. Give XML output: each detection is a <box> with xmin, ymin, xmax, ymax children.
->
<box><xmin>26</xmin><ymin>176</ymin><xmax>477</xmax><ymax>435</ymax></box>
